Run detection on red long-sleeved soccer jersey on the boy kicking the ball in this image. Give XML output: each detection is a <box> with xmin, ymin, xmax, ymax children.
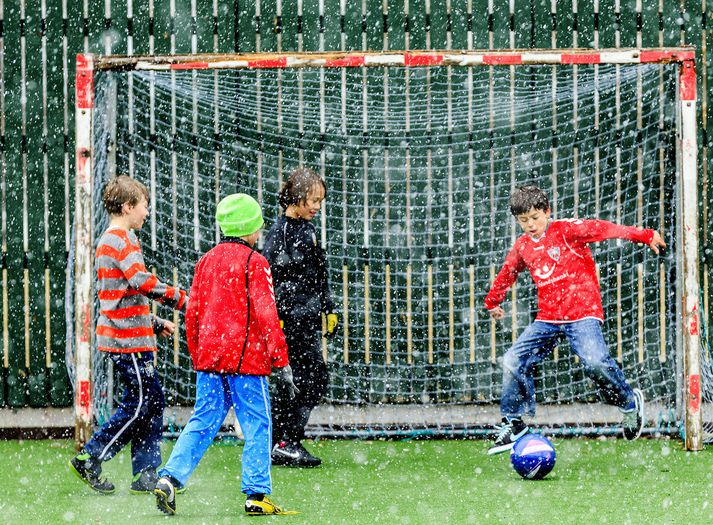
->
<box><xmin>485</xmin><ymin>219</ymin><xmax>654</xmax><ymax>323</ymax></box>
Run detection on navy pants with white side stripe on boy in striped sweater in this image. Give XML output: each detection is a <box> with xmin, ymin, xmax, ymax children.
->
<box><xmin>84</xmin><ymin>352</ymin><xmax>164</xmax><ymax>475</ymax></box>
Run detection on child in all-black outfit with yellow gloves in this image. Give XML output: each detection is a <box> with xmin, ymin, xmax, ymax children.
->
<box><xmin>263</xmin><ymin>168</ymin><xmax>339</xmax><ymax>467</ymax></box>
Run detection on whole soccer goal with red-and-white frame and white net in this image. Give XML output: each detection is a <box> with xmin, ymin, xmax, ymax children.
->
<box><xmin>67</xmin><ymin>48</ymin><xmax>708</xmax><ymax>450</ymax></box>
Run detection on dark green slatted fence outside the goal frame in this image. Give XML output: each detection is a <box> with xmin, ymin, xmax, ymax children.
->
<box><xmin>0</xmin><ymin>0</ymin><xmax>713</xmax><ymax>407</ymax></box>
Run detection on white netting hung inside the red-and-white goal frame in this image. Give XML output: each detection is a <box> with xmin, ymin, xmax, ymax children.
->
<box><xmin>79</xmin><ymin>58</ymin><xmax>680</xmax><ymax>434</ymax></box>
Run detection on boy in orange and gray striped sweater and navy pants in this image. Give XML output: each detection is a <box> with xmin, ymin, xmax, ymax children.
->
<box><xmin>70</xmin><ymin>175</ymin><xmax>186</xmax><ymax>494</ymax></box>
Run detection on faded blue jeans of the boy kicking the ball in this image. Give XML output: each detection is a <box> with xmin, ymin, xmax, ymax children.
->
<box><xmin>500</xmin><ymin>319</ymin><xmax>634</xmax><ymax>417</ymax></box>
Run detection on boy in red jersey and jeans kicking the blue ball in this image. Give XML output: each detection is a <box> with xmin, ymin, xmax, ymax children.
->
<box><xmin>485</xmin><ymin>186</ymin><xmax>666</xmax><ymax>454</ymax></box>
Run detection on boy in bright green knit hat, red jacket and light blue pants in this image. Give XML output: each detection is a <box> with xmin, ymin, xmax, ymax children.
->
<box><xmin>154</xmin><ymin>193</ymin><xmax>296</xmax><ymax>515</ymax></box>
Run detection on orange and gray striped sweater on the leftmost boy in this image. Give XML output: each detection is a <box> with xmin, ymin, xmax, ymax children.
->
<box><xmin>96</xmin><ymin>227</ymin><xmax>186</xmax><ymax>353</ymax></box>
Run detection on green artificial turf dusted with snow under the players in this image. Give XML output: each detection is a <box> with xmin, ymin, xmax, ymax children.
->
<box><xmin>0</xmin><ymin>439</ymin><xmax>713</xmax><ymax>525</ymax></box>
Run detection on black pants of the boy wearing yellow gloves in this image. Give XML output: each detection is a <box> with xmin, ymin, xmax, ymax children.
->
<box><xmin>272</xmin><ymin>321</ymin><xmax>329</xmax><ymax>445</ymax></box>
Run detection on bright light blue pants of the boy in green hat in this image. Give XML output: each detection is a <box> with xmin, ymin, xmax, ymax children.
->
<box><xmin>158</xmin><ymin>372</ymin><xmax>272</xmax><ymax>494</ymax></box>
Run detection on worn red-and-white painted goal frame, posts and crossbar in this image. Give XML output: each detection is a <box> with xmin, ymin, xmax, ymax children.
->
<box><xmin>73</xmin><ymin>47</ymin><xmax>703</xmax><ymax>450</ymax></box>
